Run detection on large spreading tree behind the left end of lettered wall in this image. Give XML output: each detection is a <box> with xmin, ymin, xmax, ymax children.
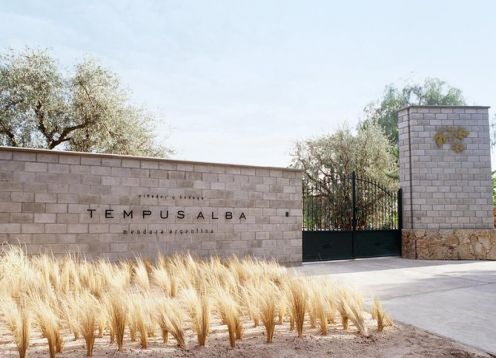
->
<box><xmin>0</xmin><ymin>49</ymin><xmax>169</xmax><ymax>156</ymax></box>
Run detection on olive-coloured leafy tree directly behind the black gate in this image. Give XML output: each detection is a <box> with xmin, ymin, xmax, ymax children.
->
<box><xmin>292</xmin><ymin>122</ymin><xmax>398</xmax><ymax>230</ymax></box>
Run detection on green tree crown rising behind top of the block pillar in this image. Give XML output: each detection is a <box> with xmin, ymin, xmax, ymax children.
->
<box><xmin>364</xmin><ymin>78</ymin><xmax>465</xmax><ymax>146</ymax></box>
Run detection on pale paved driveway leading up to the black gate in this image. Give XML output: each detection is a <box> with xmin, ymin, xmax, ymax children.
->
<box><xmin>296</xmin><ymin>257</ymin><xmax>496</xmax><ymax>354</ymax></box>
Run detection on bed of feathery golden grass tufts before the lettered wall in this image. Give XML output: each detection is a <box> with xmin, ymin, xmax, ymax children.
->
<box><xmin>0</xmin><ymin>246</ymin><xmax>392</xmax><ymax>358</ymax></box>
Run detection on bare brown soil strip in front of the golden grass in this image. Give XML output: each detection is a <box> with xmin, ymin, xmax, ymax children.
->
<box><xmin>0</xmin><ymin>321</ymin><xmax>491</xmax><ymax>358</ymax></box>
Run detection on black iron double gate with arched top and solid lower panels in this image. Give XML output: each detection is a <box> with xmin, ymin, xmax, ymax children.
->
<box><xmin>303</xmin><ymin>172</ymin><xmax>402</xmax><ymax>261</ymax></box>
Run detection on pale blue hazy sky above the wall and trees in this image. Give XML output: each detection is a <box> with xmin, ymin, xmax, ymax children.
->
<box><xmin>0</xmin><ymin>0</ymin><xmax>496</xmax><ymax>168</ymax></box>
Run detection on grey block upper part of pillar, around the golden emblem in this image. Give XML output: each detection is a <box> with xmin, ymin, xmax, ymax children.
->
<box><xmin>398</xmin><ymin>106</ymin><xmax>493</xmax><ymax>229</ymax></box>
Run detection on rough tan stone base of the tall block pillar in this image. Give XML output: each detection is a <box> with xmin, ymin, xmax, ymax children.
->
<box><xmin>401</xmin><ymin>229</ymin><xmax>496</xmax><ymax>260</ymax></box>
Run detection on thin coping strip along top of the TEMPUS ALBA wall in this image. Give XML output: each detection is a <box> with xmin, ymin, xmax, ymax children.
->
<box><xmin>0</xmin><ymin>146</ymin><xmax>303</xmax><ymax>173</ymax></box>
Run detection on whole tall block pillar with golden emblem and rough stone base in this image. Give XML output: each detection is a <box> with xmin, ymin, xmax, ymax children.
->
<box><xmin>398</xmin><ymin>106</ymin><xmax>496</xmax><ymax>259</ymax></box>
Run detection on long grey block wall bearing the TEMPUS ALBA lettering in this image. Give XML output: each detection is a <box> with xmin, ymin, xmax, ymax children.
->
<box><xmin>0</xmin><ymin>147</ymin><xmax>302</xmax><ymax>264</ymax></box>
